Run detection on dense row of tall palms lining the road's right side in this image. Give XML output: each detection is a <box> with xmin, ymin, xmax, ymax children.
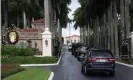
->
<box><xmin>73</xmin><ymin>0</ymin><xmax>133</xmax><ymax>61</ymax></box>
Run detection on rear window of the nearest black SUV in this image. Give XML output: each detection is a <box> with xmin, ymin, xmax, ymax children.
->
<box><xmin>91</xmin><ymin>50</ymin><xmax>113</xmax><ymax>58</ymax></box>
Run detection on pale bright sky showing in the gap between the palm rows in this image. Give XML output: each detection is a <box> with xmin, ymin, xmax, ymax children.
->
<box><xmin>62</xmin><ymin>0</ymin><xmax>80</xmax><ymax>37</ymax></box>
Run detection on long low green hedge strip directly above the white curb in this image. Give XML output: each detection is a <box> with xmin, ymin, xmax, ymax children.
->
<box><xmin>1</xmin><ymin>56</ymin><xmax>57</xmax><ymax>64</ymax></box>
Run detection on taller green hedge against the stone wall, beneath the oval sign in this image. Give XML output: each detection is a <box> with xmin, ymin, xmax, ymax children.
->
<box><xmin>1</xmin><ymin>45</ymin><xmax>35</xmax><ymax>56</ymax></box>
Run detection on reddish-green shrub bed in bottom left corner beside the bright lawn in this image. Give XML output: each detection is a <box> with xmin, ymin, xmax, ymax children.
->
<box><xmin>1</xmin><ymin>64</ymin><xmax>24</xmax><ymax>78</ymax></box>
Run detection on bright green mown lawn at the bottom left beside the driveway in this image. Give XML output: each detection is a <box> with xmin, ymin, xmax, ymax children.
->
<box><xmin>3</xmin><ymin>68</ymin><xmax>51</xmax><ymax>80</ymax></box>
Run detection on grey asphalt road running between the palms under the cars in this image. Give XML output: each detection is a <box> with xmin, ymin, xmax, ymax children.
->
<box><xmin>31</xmin><ymin>47</ymin><xmax>133</xmax><ymax>80</ymax></box>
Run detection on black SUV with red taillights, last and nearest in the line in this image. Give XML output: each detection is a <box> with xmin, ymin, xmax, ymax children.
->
<box><xmin>81</xmin><ymin>49</ymin><xmax>115</xmax><ymax>76</ymax></box>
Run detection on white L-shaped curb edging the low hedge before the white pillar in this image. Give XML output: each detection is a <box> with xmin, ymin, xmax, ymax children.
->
<box><xmin>20</xmin><ymin>54</ymin><xmax>62</xmax><ymax>67</ymax></box>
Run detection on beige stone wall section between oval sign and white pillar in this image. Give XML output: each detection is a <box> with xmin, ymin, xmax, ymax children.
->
<box><xmin>17</xmin><ymin>28</ymin><xmax>42</xmax><ymax>51</ymax></box>
